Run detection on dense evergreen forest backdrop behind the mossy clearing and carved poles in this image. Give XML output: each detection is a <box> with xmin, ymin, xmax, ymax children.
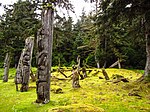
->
<box><xmin>0</xmin><ymin>0</ymin><xmax>146</xmax><ymax>69</ymax></box>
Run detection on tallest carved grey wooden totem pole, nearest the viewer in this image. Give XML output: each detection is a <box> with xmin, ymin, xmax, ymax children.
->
<box><xmin>36</xmin><ymin>8</ymin><xmax>54</xmax><ymax>104</ymax></box>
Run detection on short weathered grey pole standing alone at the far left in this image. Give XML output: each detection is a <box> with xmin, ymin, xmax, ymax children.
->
<box><xmin>3</xmin><ymin>53</ymin><xmax>10</xmax><ymax>82</ymax></box>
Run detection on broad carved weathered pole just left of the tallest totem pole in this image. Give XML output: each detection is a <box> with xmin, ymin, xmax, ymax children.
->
<box><xmin>20</xmin><ymin>37</ymin><xmax>34</xmax><ymax>92</ymax></box>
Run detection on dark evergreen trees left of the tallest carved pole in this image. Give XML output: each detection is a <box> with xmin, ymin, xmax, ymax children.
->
<box><xmin>0</xmin><ymin>0</ymin><xmax>40</xmax><ymax>67</ymax></box>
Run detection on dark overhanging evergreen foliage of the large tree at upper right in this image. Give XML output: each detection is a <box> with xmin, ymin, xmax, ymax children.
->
<box><xmin>94</xmin><ymin>0</ymin><xmax>150</xmax><ymax>76</ymax></box>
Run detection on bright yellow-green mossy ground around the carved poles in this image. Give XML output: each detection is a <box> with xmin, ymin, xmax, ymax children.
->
<box><xmin>0</xmin><ymin>68</ymin><xmax>150</xmax><ymax>112</ymax></box>
